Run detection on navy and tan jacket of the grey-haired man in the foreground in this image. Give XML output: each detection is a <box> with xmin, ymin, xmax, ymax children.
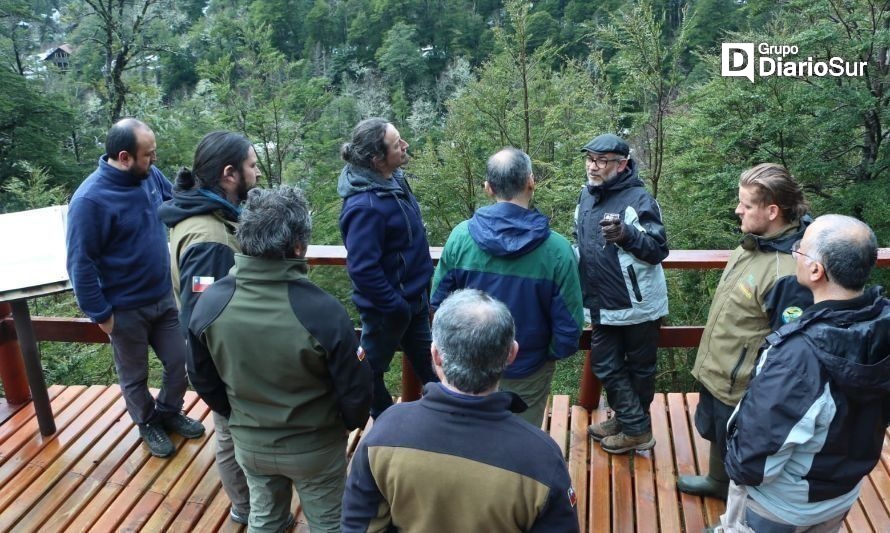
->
<box><xmin>341</xmin><ymin>383</ymin><xmax>578</xmax><ymax>533</ymax></box>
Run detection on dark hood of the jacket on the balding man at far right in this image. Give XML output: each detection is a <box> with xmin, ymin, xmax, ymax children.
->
<box><xmin>768</xmin><ymin>287</ymin><xmax>890</xmax><ymax>402</ymax></box>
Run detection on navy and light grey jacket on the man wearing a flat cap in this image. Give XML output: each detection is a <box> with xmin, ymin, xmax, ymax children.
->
<box><xmin>575</xmin><ymin>159</ymin><xmax>668</xmax><ymax>326</ymax></box>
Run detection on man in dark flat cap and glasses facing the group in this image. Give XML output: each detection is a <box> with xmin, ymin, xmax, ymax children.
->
<box><xmin>575</xmin><ymin>133</ymin><xmax>668</xmax><ymax>453</ymax></box>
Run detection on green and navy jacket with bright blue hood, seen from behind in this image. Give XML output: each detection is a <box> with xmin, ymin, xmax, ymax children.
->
<box><xmin>430</xmin><ymin>202</ymin><xmax>584</xmax><ymax>379</ymax></box>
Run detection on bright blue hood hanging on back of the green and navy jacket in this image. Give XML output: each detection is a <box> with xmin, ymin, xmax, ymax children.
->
<box><xmin>467</xmin><ymin>202</ymin><xmax>550</xmax><ymax>257</ymax></box>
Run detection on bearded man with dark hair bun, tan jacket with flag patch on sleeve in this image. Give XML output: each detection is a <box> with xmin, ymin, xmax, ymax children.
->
<box><xmin>158</xmin><ymin>131</ymin><xmax>260</xmax><ymax>524</ymax></box>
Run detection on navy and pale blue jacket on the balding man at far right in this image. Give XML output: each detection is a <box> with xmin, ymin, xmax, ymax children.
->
<box><xmin>726</xmin><ymin>287</ymin><xmax>890</xmax><ymax>526</ymax></box>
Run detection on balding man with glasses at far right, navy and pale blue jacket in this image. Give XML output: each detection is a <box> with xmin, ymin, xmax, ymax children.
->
<box><xmin>724</xmin><ymin>215</ymin><xmax>890</xmax><ymax>533</ymax></box>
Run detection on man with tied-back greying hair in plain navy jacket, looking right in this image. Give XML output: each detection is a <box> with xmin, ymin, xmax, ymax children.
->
<box><xmin>337</xmin><ymin>117</ymin><xmax>437</xmax><ymax>418</ymax></box>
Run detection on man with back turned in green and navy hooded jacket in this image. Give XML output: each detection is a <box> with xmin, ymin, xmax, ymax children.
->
<box><xmin>430</xmin><ymin>148</ymin><xmax>584</xmax><ymax>426</ymax></box>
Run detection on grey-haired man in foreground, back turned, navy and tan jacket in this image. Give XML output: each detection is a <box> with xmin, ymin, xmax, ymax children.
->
<box><xmin>342</xmin><ymin>289</ymin><xmax>578</xmax><ymax>532</ymax></box>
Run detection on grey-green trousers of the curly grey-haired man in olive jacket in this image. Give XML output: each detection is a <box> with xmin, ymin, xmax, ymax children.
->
<box><xmin>235</xmin><ymin>435</ymin><xmax>346</xmax><ymax>533</ymax></box>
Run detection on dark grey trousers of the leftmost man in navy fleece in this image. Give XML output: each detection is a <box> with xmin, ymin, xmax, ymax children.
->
<box><xmin>109</xmin><ymin>290</ymin><xmax>188</xmax><ymax>424</ymax></box>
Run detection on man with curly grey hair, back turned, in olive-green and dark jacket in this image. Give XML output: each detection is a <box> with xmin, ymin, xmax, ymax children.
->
<box><xmin>188</xmin><ymin>186</ymin><xmax>371</xmax><ymax>532</ymax></box>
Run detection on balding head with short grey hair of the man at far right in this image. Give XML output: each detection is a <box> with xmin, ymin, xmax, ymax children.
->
<box><xmin>802</xmin><ymin>215</ymin><xmax>878</xmax><ymax>291</ymax></box>
